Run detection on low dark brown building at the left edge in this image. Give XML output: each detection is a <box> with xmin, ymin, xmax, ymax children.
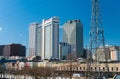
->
<box><xmin>0</xmin><ymin>44</ymin><xmax>26</xmax><ymax>57</ymax></box>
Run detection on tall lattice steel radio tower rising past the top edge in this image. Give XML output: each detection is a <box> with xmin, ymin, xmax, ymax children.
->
<box><xmin>87</xmin><ymin>0</ymin><xmax>109</xmax><ymax>77</ymax></box>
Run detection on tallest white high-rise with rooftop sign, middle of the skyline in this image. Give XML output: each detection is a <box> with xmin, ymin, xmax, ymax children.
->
<box><xmin>42</xmin><ymin>17</ymin><xmax>59</xmax><ymax>59</ymax></box>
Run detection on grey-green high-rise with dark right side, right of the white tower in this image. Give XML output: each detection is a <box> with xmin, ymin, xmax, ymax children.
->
<box><xmin>63</xmin><ymin>20</ymin><xmax>83</xmax><ymax>58</ymax></box>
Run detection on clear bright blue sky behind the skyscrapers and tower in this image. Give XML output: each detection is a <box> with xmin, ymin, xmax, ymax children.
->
<box><xmin>0</xmin><ymin>0</ymin><xmax>120</xmax><ymax>51</ymax></box>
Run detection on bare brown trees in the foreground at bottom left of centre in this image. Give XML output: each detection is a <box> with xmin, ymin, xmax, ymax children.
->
<box><xmin>14</xmin><ymin>67</ymin><xmax>55</xmax><ymax>79</ymax></box>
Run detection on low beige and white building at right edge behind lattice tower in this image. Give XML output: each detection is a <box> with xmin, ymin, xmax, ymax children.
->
<box><xmin>95</xmin><ymin>46</ymin><xmax>120</xmax><ymax>62</ymax></box>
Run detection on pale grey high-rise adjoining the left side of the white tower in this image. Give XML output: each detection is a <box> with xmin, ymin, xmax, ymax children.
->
<box><xmin>29</xmin><ymin>23</ymin><xmax>42</xmax><ymax>56</ymax></box>
